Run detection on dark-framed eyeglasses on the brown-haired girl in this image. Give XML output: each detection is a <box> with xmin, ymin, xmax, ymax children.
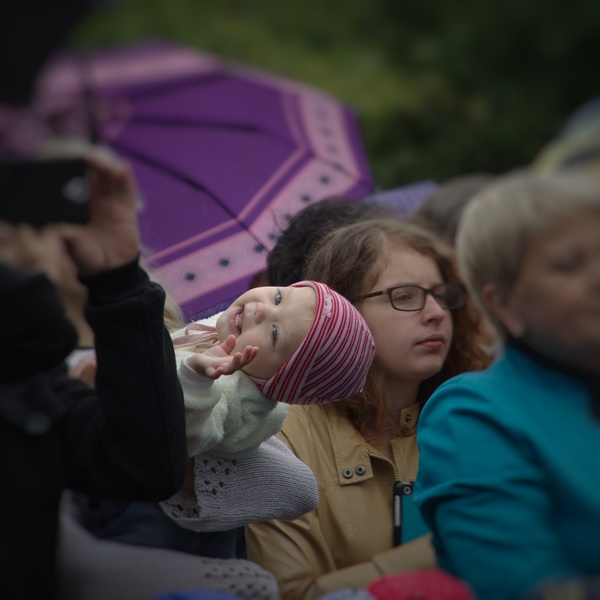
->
<box><xmin>352</xmin><ymin>283</ymin><xmax>465</xmax><ymax>311</ymax></box>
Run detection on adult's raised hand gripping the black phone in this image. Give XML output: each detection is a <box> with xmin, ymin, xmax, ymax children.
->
<box><xmin>61</xmin><ymin>150</ymin><xmax>140</xmax><ymax>277</ymax></box>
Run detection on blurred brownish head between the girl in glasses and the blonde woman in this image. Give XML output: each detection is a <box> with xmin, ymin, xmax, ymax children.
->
<box><xmin>409</xmin><ymin>173</ymin><xmax>494</xmax><ymax>244</ymax></box>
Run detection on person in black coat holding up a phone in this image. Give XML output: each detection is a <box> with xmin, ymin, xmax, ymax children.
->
<box><xmin>0</xmin><ymin>155</ymin><xmax>187</xmax><ymax>598</ymax></box>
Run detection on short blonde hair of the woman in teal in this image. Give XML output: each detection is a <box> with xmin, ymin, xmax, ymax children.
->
<box><xmin>456</xmin><ymin>171</ymin><xmax>600</xmax><ymax>339</ymax></box>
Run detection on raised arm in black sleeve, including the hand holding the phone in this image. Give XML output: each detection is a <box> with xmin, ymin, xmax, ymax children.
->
<box><xmin>60</xmin><ymin>154</ymin><xmax>187</xmax><ymax>500</ymax></box>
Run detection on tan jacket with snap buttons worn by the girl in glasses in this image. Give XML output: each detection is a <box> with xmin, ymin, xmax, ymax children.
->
<box><xmin>246</xmin><ymin>404</ymin><xmax>435</xmax><ymax>600</ymax></box>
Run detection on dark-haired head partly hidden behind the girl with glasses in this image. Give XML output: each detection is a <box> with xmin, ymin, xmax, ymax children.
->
<box><xmin>267</xmin><ymin>197</ymin><xmax>387</xmax><ymax>286</ymax></box>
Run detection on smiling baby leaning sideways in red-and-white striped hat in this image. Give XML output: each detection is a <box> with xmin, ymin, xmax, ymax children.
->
<box><xmin>172</xmin><ymin>281</ymin><xmax>375</xmax><ymax>458</ymax></box>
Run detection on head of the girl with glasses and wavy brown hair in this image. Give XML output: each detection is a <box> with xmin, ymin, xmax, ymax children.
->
<box><xmin>306</xmin><ymin>217</ymin><xmax>488</xmax><ymax>435</ymax></box>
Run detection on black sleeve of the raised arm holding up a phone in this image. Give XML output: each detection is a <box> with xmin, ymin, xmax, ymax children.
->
<box><xmin>60</xmin><ymin>261</ymin><xmax>188</xmax><ymax>501</ymax></box>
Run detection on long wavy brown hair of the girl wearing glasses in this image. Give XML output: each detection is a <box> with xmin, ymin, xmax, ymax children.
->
<box><xmin>304</xmin><ymin>218</ymin><xmax>489</xmax><ymax>438</ymax></box>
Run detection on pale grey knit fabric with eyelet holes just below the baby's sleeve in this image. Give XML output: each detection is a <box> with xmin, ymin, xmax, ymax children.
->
<box><xmin>160</xmin><ymin>437</ymin><xmax>319</xmax><ymax>531</ymax></box>
